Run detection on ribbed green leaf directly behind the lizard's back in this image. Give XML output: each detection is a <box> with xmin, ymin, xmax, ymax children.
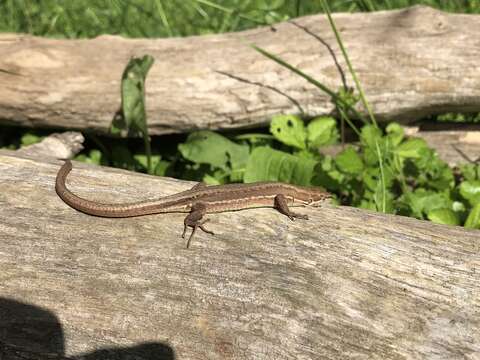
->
<box><xmin>244</xmin><ymin>147</ymin><xmax>317</xmax><ymax>185</ymax></box>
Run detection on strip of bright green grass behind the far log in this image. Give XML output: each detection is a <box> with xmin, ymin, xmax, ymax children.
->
<box><xmin>0</xmin><ymin>0</ymin><xmax>480</xmax><ymax>38</ymax></box>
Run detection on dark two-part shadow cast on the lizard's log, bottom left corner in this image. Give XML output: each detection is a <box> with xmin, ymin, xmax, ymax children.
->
<box><xmin>0</xmin><ymin>297</ymin><xmax>175</xmax><ymax>360</ymax></box>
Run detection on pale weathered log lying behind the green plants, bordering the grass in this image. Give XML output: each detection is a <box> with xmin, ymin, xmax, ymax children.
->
<box><xmin>0</xmin><ymin>6</ymin><xmax>480</xmax><ymax>134</ymax></box>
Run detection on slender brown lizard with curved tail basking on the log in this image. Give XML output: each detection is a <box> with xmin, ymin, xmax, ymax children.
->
<box><xmin>55</xmin><ymin>160</ymin><xmax>332</xmax><ymax>248</ymax></box>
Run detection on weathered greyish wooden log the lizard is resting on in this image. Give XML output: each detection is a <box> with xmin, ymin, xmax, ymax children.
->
<box><xmin>0</xmin><ymin>151</ymin><xmax>480</xmax><ymax>359</ymax></box>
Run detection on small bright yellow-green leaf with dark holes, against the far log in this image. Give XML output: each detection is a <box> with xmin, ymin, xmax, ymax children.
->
<box><xmin>270</xmin><ymin>115</ymin><xmax>307</xmax><ymax>150</ymax></box>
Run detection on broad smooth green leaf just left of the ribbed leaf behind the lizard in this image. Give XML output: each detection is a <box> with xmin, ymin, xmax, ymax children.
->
<box><xmin>178</xmin><ymin>130</ymin><xmax>249</xmax><ymax>170</ymax></box>
